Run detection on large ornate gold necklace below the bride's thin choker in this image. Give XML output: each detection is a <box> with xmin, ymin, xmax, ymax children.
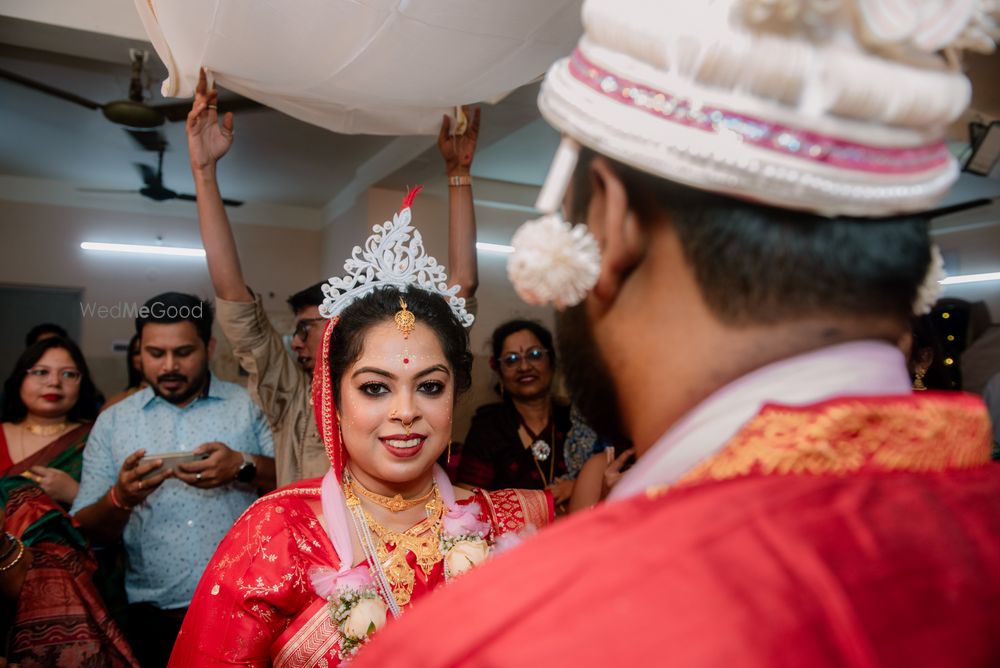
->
<box><xmin>343</xmin><ymin>476</ymin><xmax>444</xmax><ymax>606</ymax></box>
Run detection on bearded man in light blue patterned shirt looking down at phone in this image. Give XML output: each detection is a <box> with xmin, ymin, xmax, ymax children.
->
<box><xmin>72</xmin><ymin>292</ymin><xmax>274</xmax><ymax>668</ymax></box>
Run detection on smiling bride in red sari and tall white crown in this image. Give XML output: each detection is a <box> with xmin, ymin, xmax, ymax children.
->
<box><xmin>170</xmin><ymin>130</ymin><xmax>553</xmax><ymax>666</ymax></box>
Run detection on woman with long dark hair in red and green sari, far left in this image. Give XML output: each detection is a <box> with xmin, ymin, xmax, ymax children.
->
<box><xmin>0</xmin><ymin>337</ymin><xmax>138</xmax><ymax>666</ymax></box>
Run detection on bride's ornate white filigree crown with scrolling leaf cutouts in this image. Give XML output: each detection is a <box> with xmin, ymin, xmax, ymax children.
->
<box><xmin>319</xmin><ymin>198</ymin><xmax>475</xmax><ymax>327</ymax></box>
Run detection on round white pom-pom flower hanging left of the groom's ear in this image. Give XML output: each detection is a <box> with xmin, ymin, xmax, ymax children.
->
<box><xmin>507</xmin><ymin>214</ymin><xmax>601</xmax><ymax>309</ymax></box>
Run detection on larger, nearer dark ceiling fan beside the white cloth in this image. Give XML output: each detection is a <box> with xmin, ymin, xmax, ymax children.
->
<box><xmin>0</xmin><ymin>49</ymin><xmax>262</xmax><ymax>130</ymax></box>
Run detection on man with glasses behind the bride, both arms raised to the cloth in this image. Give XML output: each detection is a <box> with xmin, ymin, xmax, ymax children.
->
<box><xmin>187</xmin><ymin>73</ymin><xmax>479</xmax><ymax>487</ymax></box>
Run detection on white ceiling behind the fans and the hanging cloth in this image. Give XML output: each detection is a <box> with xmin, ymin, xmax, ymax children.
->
<box><xmin>0</xmin><ymin>0</ymin><xmax>1000</xmax><ymax>232</ymax></box>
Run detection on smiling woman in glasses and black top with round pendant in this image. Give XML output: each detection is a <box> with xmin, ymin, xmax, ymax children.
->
<box><xmin>456</xmin><ymin>320</ymin><xmax>590</xmax><ymax>509</ymax></box>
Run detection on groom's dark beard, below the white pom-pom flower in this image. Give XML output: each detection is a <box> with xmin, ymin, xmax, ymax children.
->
<box><xmin>556</xmin><ymin>304</ymin><xmax>630</xmax><ymax>445</ymax></box>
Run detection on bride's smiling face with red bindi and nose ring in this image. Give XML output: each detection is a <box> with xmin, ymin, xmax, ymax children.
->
<box><xmin>339</xmin><ymin>320</ymin><xmax>455</xmax><ymax>493</ymax></box>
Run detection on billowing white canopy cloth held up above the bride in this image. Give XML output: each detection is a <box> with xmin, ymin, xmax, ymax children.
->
<box><xmin>135</xmin><ymin>0</ymin><xmax>582</xmax><ymax>135</ymax></box>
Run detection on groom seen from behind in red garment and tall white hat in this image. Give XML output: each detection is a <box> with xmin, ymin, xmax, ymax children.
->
<box><xmin>356</xmin><ymin>0</ymin><xmax>1000</xmax><ymax>668</ymax></box>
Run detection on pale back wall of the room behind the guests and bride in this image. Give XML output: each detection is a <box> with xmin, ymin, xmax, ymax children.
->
<box><xmin>0</xmin><ymin>183</ymin><xmax>552</xmax><ymax>440</ymax></box>
